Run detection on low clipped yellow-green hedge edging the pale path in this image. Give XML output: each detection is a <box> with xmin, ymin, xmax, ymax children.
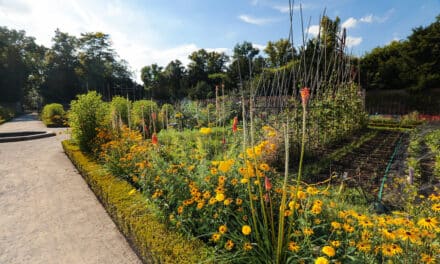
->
<box><xmin>62</xmin><ymin>140</ymin><xmax>213</xmax><ymax>263</ymax></box>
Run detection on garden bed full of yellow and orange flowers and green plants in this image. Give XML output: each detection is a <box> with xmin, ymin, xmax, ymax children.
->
<box><xmin>62</xmin><ymin>89</ymin><xmax>440</xmax><ymax>263</ymax></box>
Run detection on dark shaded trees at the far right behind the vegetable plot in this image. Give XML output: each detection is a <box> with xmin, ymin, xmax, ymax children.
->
<box><xmin>361</xmin><ymin>15</ymin><xmax>440</xmax><ymax>92</ymax></box>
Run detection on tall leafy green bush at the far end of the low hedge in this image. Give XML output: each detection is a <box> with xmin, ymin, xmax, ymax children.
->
<box><xmin>69</xmin><ymin>91</ymin><xmax>108</xmax><ymax>152</ymax></box>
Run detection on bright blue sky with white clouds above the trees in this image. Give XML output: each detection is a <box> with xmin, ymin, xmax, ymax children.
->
<box><xmin>0</xmin><ymin>0</ymin><xmax>440</xmax><ymax>81</ymax></box>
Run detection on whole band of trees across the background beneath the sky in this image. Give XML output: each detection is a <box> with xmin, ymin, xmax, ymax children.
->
<box><xmin>0</xmin><ymin>16</ymin><xmax>440</xmax><ymax>107</ymax></box>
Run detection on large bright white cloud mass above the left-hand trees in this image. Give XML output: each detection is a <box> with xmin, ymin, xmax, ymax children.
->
<box><xmin>0</xmin><ymin>0</ymin><xmax>227</xmax><ymax>82</ymax></box>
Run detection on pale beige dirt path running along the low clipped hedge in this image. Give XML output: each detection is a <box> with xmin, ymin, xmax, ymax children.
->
<box><xmin>0</xmin><ymin>115</ymin><xmax>140</xmax><ymax>264</ymax></box>
